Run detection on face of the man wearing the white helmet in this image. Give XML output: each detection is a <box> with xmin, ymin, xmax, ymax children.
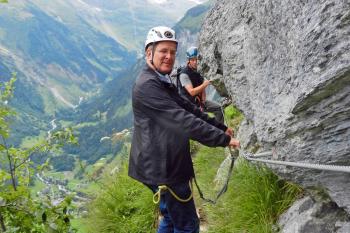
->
<box><xmin>147</xmin><ymin>41</ymin><xmax>177</xmax><ymax>74</ymax></box>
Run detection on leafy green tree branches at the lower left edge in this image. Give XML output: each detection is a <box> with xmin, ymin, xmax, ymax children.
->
<box><xmin>0</xmin><ymin>75</ymin><xmax>77</xmax><ymax>233</ymax></box>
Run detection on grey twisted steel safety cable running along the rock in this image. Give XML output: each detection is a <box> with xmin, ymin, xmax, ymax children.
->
<box><xmin>242</xmin><ymin>151</ymin><xmax>350</xmax><ymax>173</ymax></box>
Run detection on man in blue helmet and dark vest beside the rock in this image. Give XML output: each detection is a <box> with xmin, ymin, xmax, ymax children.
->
<box><xmin>180</xmin><ymin>47</ymin><xmax>224</xmax><ymax>123</ymax></box>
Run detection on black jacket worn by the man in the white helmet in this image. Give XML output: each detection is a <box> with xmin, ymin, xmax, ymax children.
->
<box><xmin>129</xmin><ymin>65</ymin><xmax>230</xmax><ymax>185</ymax></box>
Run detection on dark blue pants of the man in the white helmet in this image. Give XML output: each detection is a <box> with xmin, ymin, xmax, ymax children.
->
<box><xmin>147</xmin><ymin>182</ymin><xmax>199</xmax><ymax>233</ymax></box>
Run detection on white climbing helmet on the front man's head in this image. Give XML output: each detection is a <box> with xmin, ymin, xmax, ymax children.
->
<box><xmin>145</xmin><ymin>26</ymin><xmax>178</xmax><ymax>50</ymax></box>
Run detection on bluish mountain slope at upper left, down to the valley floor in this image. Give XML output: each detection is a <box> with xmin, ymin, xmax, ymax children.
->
<box><xmin>0</xmin><ymin>1</ymin><xmax>135</xmax><ymax>144</ymax></box>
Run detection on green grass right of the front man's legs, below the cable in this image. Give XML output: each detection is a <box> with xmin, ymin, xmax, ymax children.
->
<box><xmin>195</xmin><ymin>147</ymin><xmax>301</xmax><ymax>233</ymax></box>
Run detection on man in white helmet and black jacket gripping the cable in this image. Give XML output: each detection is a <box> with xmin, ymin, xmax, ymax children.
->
<box><xmin>129</xmin><ymin>27</ymin><xmax>239</xmax><ymax>233</ymax></box>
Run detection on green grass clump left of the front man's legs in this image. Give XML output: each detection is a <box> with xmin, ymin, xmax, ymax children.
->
<box><xmin>72</xmin><ymin>145</ymin><xmax>156</xmax><ymax>233</ymax></box>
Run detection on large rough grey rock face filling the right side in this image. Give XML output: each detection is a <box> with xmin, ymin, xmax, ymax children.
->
<box><xmin>199</xmin><ymin>0</ymin><xmax>350</xmax><ymax>229</ymax></box>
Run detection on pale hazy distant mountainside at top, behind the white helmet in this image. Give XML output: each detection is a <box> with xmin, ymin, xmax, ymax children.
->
<box><xmin>21</xmin><ymin>0</ymin><xmax>200</xmax><ymax>52</ymax></box>
